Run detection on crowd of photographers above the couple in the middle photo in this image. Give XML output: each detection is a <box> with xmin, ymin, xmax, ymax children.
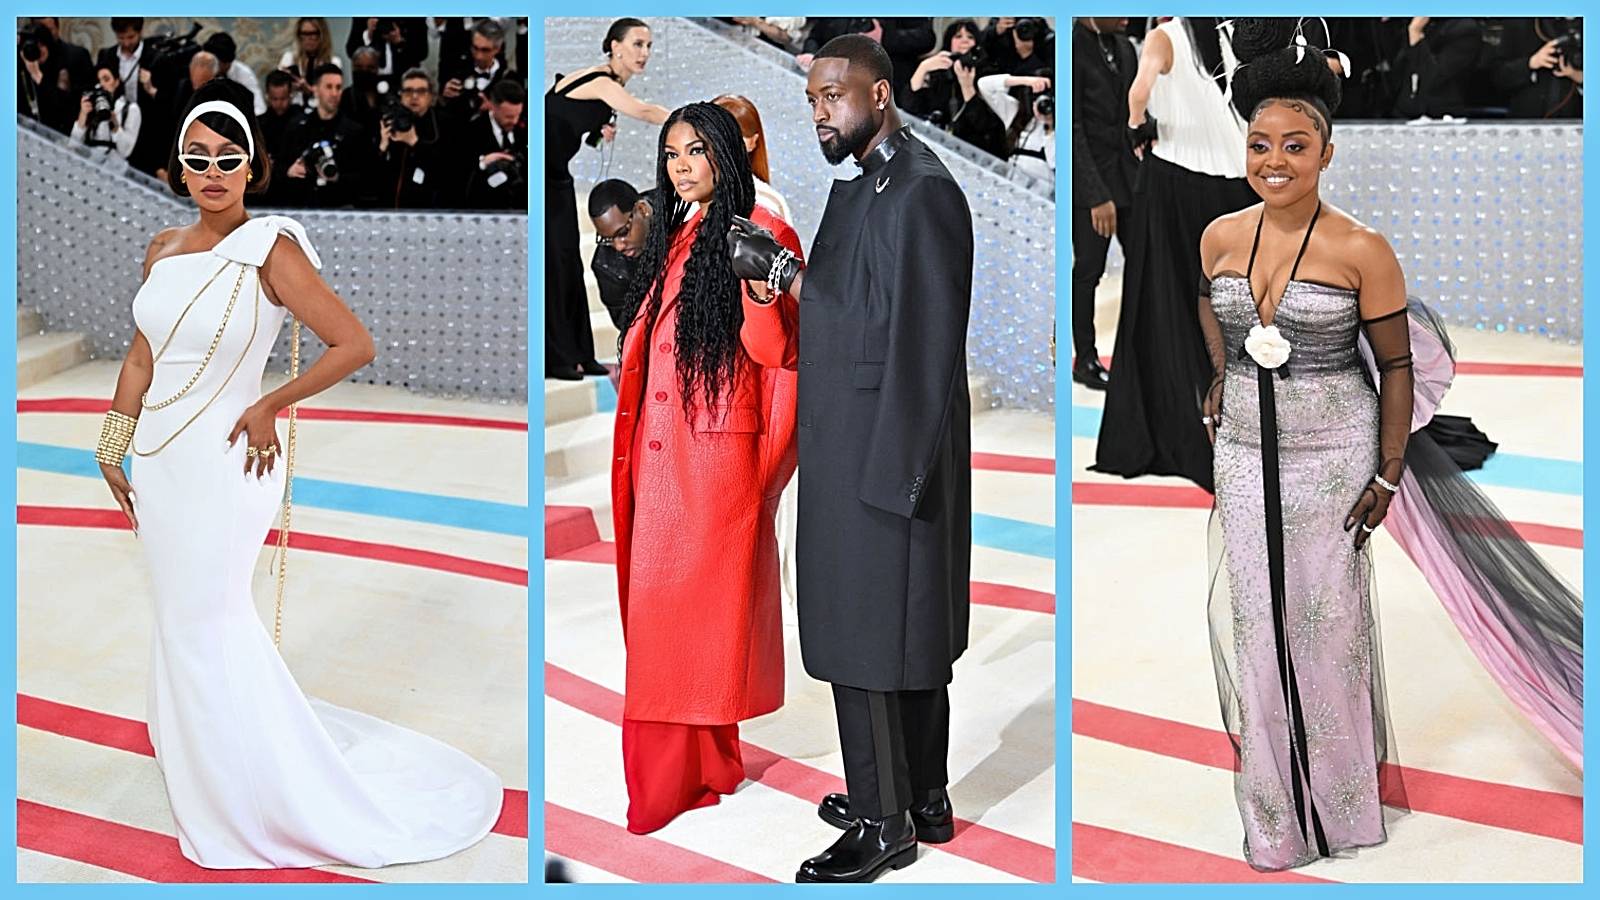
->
<box><xmin>725</xmin><ymin>16</ymin><xmax>1056</xmax><ymax>191</ymax></box>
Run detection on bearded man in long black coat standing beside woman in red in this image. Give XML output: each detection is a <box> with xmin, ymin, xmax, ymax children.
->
<box><xmin>728</xmin><ymin>35</ymin><xmax>973</xmax><ymax>882</ymax></box>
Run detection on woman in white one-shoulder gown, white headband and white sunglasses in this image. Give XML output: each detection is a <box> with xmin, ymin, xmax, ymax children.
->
<box><xmin>96</xmin><ymin>78</ymin><xmax>502</xmax><ymax>868</ymax></box>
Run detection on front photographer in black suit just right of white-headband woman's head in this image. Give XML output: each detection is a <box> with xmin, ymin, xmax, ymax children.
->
<box><xmin>272</xmin><ymin>62</ymin><xmax>374</xmax><ymax>210</ymax></box>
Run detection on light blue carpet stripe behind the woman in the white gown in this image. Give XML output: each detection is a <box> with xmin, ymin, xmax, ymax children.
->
<box><xmin>16</xmin><ymin>442</ymin><xmax>533</xmax><ymax>536</ymax></box>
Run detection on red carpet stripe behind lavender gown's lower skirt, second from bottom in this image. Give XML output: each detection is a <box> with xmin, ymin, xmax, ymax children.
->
<box><xmin>1072</xmin><ymin>698</ymin><xmax>1584</xmax><ymax>844</ymax></box>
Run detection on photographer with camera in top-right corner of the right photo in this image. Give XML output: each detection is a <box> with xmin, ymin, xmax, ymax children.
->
<box><xmin>1491</xmin><ymin>18</ymin><xmax>1584</xmax><ymax>119</ymax></box>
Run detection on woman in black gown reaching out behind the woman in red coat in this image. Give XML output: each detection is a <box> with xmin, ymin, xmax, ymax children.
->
<box><xmin>544</xmin><ymin>19</ymin><xmax>667</xmax><ymax>381</ymax></box>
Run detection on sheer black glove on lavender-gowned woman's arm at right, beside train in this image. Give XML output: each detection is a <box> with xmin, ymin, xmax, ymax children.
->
<box><xmin>1344</xmin><ymin>309</ymin><xmax>1411</xmax><ymax>548</ymax></box>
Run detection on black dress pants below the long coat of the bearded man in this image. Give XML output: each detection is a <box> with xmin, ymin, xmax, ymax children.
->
<box><xmin>834</xmin><ymin>684</ymin><xmax>950</xmax><ymax>820</ymax></box>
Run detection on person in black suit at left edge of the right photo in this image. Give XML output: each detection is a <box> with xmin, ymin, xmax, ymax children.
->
<box><xmin>1072</xmin><ymin>18</ymin><xmax>1139</xmax><ymax>391</ymax></box>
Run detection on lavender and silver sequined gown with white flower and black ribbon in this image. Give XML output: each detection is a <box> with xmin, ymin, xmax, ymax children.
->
<box><xmin>1210</xmin><ymin>275</ymin><xmax>1389</xmax><ymax>870</ymax></box>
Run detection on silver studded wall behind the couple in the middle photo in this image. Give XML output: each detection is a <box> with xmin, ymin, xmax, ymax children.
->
<box><xmin>541</xmin><ymin>18</ymin><xmax>1056</xmax><ymax>410</ymax></box>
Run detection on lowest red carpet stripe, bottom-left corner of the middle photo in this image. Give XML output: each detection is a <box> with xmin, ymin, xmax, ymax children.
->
<box><xmin>544</xmin><ymin>802</ymin><xmax>773</xmax><ymax>884</ymax></box>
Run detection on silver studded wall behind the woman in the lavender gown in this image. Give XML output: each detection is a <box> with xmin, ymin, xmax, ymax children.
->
<box><xmin>1107</xmin><ymin>122</ymin><xmax>1584</xmax><ymax>344</ymax></box>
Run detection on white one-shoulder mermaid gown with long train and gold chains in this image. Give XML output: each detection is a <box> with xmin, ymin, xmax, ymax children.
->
<box><xmin>131</xmin><ymin>216</ymin><xmax>502</xmax><ymax>868</ymax></box>
